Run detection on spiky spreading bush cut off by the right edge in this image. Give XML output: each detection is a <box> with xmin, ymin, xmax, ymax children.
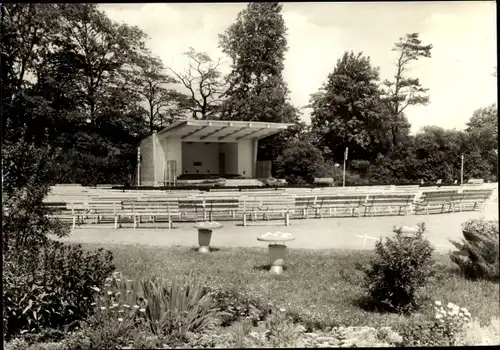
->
<box><xmin>450</xmin><ymin>219</ymin><xmax>500</xmax><ymax>281</ymax></box>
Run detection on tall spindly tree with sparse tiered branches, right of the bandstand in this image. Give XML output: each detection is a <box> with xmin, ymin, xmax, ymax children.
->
<box><xmin>383</xmin><ymin>33</ymin><xmax>432</xmax><ymax>146</ymax></box>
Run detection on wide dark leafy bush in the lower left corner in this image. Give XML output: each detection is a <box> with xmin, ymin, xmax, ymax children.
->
<box><xmin>3</xmin><ymin>241</ymin><xmax>114</xmax><ymax>338</ymax></box>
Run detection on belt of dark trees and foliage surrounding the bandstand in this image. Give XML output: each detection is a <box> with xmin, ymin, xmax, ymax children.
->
<box><xmin>1</xmin><ymin>3</ymin><xmax>498</xmax><ymax>185</ymax></box>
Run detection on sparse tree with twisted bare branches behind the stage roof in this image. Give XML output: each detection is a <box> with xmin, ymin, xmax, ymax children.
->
<box><xmin>170</xmin><ymin>47</ymin><xmax>225</xmax><ymax>119</ymax></box>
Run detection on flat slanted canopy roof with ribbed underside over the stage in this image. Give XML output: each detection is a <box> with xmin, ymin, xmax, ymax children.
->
<box><xmin>158</xmin><ymin>120</ymin><xmax>293</xmax><ymax>142</ymax></box>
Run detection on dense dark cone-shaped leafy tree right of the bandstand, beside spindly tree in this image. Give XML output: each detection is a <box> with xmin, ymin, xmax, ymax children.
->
<box><xmin>310</xmin><ymin>52</ymin><xmax>386</xmax><ymax>161</ymax></box>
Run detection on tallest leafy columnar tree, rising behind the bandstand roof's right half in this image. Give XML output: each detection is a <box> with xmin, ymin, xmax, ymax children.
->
<box><xmin>219</xmin><ymin>2</ymin><xmax>302</xmax><ymax>171</ymax></box>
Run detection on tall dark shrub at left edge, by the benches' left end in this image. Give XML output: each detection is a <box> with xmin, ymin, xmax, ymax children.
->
<box><xmin>2</xmin><ymin>141</ymin><xmax>69</xmax><ymax>254</ymax></box>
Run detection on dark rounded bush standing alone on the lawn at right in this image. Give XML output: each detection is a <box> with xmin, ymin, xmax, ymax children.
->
<box><xmin>358</xmin><ymin>223</ymin><xmax>434</xmax><ymax>313</ymax></box>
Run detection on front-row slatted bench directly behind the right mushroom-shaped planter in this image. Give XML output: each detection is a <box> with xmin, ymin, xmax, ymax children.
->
<box><xmin>241</xmin><ymin>195</ymin><xmax>294</xmax><ymax>226</ymax></box>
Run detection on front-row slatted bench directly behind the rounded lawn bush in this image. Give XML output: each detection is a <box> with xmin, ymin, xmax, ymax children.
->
<box><xmin>362</xmin><ymin>192</ymin><xmax>416</xmax><ymax>216</ymax></box>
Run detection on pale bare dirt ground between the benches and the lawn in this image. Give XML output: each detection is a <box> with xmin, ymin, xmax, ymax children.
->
<box><xmin>57</xmin><ymin>201</ymin><xmax>498</xmax><ymax>252</ymax></box>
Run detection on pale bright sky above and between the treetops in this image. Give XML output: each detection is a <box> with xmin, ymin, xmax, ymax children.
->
<box><xmin>100</xmin><ymin>1</ymin><xmax>497</xmax><ymax>133</ymax></box>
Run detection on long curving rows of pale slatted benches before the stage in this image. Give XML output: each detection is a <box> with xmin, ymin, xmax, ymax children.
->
<box><xmin>46</xmin><ymin>189</ymin><xmax>493</xmax><ymax>228</ymax></box>
